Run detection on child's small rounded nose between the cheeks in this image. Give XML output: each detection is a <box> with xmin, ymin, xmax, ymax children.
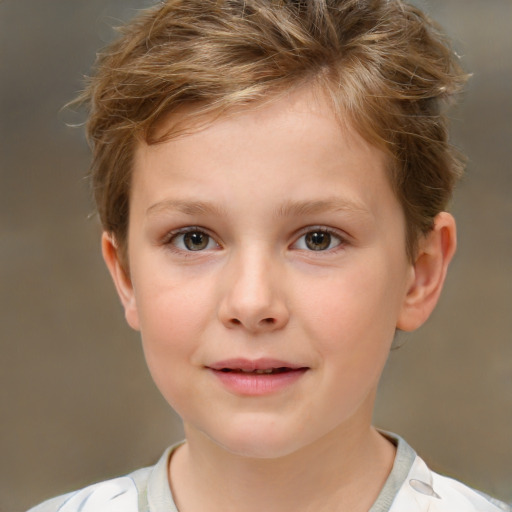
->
<box><xmin>218</xmin><ymin>250</ymin><xmax>289</xmax><ymax>334</ymax></box>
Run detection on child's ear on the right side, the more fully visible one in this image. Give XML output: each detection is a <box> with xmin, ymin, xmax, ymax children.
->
<box><xmin>397</xmin><ymin>212</ymin><xmax>457</xmax><ymax>331</ymax></box>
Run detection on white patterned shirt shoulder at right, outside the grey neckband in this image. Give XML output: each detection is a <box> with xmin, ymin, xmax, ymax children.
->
<box><xmin>389</xmin><ymin>457</ymin><xmax>512</xmax><ymax>512</ymax></box>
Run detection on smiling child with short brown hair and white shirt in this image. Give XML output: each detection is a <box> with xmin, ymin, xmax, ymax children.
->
<box><xmin>28</xmin><ymin>0</ymin><xmax>510</xmax><ymax>512</ymax></box>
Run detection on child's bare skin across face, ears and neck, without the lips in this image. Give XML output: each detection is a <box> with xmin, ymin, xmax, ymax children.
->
<box><xmin>103</xmin><ymin>89</ymin><xmax>455</xmax><ymax>512</ymax></box>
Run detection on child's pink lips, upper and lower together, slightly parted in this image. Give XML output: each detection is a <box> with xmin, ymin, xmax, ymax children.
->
<box><xmin>206</xmin><ymin>358</ymin><xmax>309</xmax><ymax>396</ymax></box>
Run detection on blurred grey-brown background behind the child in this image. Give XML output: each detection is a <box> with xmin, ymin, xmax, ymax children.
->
<box><xmin>0</xmin><ymin>0</ymin><xmax>512</xmax><ymax>512</ymax></box>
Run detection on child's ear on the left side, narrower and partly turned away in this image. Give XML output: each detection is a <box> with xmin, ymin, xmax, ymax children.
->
<box><xmin>101</xmin><ymin>231</ymin><xmax>140</xmax><ymax>331</ymax></box>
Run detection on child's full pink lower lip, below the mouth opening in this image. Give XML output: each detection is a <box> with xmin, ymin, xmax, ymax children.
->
<box><xmin>210</xmin><ymin>368</ymin><xmax>307</xmax><ymax>396</ymax></box>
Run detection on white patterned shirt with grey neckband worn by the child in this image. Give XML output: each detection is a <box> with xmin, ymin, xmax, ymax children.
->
<box><xmin>28</xmin><ymin>433</ymin><xmax>512</xmax><ymax>512</ymax></box>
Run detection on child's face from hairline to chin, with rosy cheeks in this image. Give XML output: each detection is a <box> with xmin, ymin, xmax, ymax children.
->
<box><xmin>110</xmin><ymin>90</ymin><xmax>418</xmax><ymax>457</ymax></box>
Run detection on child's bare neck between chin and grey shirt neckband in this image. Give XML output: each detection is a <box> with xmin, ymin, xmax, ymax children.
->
<box><xmin>170</xmin><ymin>418</ymin><xmax>395</xmax><ymax>512</ymax></box>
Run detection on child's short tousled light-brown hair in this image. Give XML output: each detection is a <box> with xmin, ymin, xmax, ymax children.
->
<box><xmin>79</xmin><ymin>0</ymin><xmax>466</xmax><ymax>264</ymax></box>
